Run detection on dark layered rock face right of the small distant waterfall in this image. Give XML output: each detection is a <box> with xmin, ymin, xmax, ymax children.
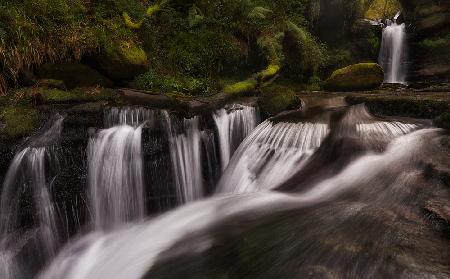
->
<box><xmin>400</xmin><ymin>0</ymin><xmax>450</xmax><ymax>82</ymax></box>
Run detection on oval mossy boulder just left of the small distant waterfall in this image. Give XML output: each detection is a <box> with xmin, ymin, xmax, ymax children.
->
<box><xmin>324</xmin><ymin>63</ymin><xmax>384</xmax><ymax>92</ymax></box>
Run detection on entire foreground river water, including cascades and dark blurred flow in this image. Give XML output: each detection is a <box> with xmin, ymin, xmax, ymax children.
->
<box><xmin>0</xmin><ymin>99</ymin><xmax>450</xmax><ymax>279</ymax></box>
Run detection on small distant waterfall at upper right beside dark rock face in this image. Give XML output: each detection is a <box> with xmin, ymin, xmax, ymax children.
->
<box><xmin>378</xmin><ymin>13</ymin><xmax>407</xmax><ymax>84</ymax></box>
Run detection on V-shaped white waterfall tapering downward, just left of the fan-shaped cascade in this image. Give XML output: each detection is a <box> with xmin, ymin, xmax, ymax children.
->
<box><xmin>213</xmin><ymin>104</ymin><xmax>260</xmax><ymax>170</ymax></box>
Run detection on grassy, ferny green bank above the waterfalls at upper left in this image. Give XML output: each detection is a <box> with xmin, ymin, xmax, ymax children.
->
<box><xmin>0</xmin><ymin>0</ymin><xmax>384</xmax><ymax>95</ymax></box>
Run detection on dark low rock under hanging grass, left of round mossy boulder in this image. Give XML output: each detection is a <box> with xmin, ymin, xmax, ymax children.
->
<box><xmin>37</xmin><ymin>62</ymin><xmax>113</xmax><ymax>88</ymax></box>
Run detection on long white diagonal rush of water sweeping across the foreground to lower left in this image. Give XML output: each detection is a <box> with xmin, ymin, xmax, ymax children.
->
<box><xmin>40</xmin><ymin>130</ymin><xmax>436</xmax><ymax>279</ymax></box>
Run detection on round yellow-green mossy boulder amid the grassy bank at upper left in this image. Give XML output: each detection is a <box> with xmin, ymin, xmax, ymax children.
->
<box><xmin>97</xmin><ymin>41</ymin><xmax>149</xmax><ymax>81</ymax></box>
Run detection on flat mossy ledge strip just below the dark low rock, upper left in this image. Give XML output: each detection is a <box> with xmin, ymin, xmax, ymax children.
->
<box><xmin>37</xmin><ymin>88</ymin><xmax>116</xmax><ymax>104</ymax></box>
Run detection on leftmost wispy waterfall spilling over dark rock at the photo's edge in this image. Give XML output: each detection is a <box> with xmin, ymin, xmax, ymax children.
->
<box><xmin>0</xmin><ymin>115</ymin><xmax>64</xmax><ymax>278</ymax></box>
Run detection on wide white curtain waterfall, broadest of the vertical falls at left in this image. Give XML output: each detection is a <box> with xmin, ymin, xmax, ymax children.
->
<box><xmin>88</xmin><ymin>125</ymin><xmax>145</xmax><ymax>230</ymax></box>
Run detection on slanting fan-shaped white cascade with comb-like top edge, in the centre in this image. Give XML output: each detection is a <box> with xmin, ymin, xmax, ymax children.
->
<box><xmin>217</xmin><ymin>120</ymin><xmax>328</xmax><ymax>193</ymax></box>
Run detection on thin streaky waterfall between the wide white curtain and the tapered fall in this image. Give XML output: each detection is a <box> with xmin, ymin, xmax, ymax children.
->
<box><xmin>163</xmin><ymin>111</ymin><xmax>204</xmax><ymax>204</ymax></box>
